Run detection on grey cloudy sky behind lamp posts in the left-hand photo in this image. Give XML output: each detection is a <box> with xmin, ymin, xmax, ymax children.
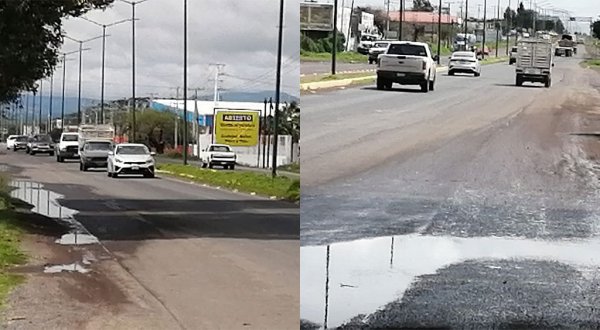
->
<box><xmin>51</xmin><ymin>0</ymin><xmax>300</xmax><ymax>99</ymax></box>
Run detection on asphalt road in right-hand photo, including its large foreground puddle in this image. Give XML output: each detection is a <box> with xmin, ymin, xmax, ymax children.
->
<box><xmin>300</xmin><ymin>47</ymin><xmax>600</xmax><ymax>329</ymax></box>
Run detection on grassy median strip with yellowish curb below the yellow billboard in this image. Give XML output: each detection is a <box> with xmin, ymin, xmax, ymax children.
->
<box><xmin>157</xmin><ymin>164</ymin><xmax>300</xmax><ymax>202</ymax></box>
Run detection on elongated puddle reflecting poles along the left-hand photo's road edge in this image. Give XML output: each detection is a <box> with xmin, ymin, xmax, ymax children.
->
<box><xmin>11</xmin><ymin>181</ymin><xmax>99</xmax><ymax>245</ymax></box>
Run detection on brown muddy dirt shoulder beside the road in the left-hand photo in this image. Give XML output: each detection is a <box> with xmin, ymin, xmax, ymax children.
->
<box><xmin>2</xmin><ymin>214</ymin><xmax>178</xmax><ymax>329</ymax></box>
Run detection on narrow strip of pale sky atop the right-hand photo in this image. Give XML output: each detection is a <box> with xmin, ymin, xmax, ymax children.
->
<box><xmin>354</xmin><ymin>0</ymin><xmax>600</xmax><ymax>32</ymax></box>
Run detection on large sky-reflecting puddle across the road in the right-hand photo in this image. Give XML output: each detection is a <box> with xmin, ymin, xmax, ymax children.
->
<box><xmin>300</xmin><ymin>234</ymin><xmax>600</xmax><ymax>328</ymax></box>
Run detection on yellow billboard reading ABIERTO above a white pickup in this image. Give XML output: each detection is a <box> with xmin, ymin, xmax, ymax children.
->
<box><xmin>215</xmin><ymin>110</ymin><xmax>260</xmax><ymax>147</ymax></box>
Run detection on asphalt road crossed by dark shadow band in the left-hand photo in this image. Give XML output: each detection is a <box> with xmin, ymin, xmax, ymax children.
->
<box><xmin>0</xmin><ymin>151</ymin><xmax>299</xmax><ymax>329</ymax></box>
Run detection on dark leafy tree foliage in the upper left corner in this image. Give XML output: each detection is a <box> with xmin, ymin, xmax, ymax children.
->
<box><xmin>0</xmin><ymin>0</ymin><xmax>114</xmax><ymax>102</ymax></box>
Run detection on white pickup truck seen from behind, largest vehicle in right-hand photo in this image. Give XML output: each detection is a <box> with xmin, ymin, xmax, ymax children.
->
<box><xmin>377</xmin><ymin>41</ymin><xmax>438</xmax><ymax>93</ymax></box>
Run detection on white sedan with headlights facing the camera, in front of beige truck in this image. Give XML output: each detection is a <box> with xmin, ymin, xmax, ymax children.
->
<box><xmin>107</xmin><ymin>143</ymin><xmax>155</xmax><ymax>178</ymax></box>
